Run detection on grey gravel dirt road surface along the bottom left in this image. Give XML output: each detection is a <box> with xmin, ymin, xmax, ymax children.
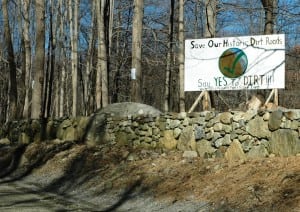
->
<box><xmin>0</xmin><ymin>182</ymin><xmax>209</xmax><ymax>212</ymax></box>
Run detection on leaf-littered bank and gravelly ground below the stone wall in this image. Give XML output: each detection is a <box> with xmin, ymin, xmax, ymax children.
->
<box><xmin>0</xmin><ymin>144</ymin><xmax>300</xmax><ymax>212</ymax></box>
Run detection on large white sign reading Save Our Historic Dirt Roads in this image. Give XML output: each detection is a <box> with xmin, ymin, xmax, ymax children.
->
<box><xmin>184</xmin><ymin>34</ymin><xmax>285</xmax><ymax>91</ymax></box>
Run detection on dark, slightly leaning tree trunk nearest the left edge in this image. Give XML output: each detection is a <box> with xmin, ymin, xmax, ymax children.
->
<box><xmin>2</xmin><ymin>0</ymin><xmax>18</xmax><ymax>120</ymax></box>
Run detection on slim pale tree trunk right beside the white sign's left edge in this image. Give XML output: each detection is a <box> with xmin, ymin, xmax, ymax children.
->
<box><xmin>178</xmin><ymin>0</ymin><xmax>185</xmax><ymax>112</ymax></box>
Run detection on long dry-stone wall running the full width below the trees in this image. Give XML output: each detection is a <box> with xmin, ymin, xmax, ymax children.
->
<box><xmin>0</xmin><ymin>110</ymin><xmax>300</xmax><ymax>160</ymax></box>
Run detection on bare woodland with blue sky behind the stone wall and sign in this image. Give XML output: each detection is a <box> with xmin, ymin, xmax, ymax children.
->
<box><xmin>0</xmin><ymin>0</ymin><xmax>300</xmax><ymax>123</ymax></box>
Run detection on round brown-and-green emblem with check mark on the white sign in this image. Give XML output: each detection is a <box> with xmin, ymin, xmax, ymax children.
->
<box><xmin>219</xmin><ymin>48</ymin><xmax>248</xmax><ymax>78</ymax></box>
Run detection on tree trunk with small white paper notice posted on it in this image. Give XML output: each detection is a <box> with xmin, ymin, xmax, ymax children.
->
<box><xmin>131</xmin><ymin>0</ymin><xmax>144</xmax><ymax>102</ymax></box>
